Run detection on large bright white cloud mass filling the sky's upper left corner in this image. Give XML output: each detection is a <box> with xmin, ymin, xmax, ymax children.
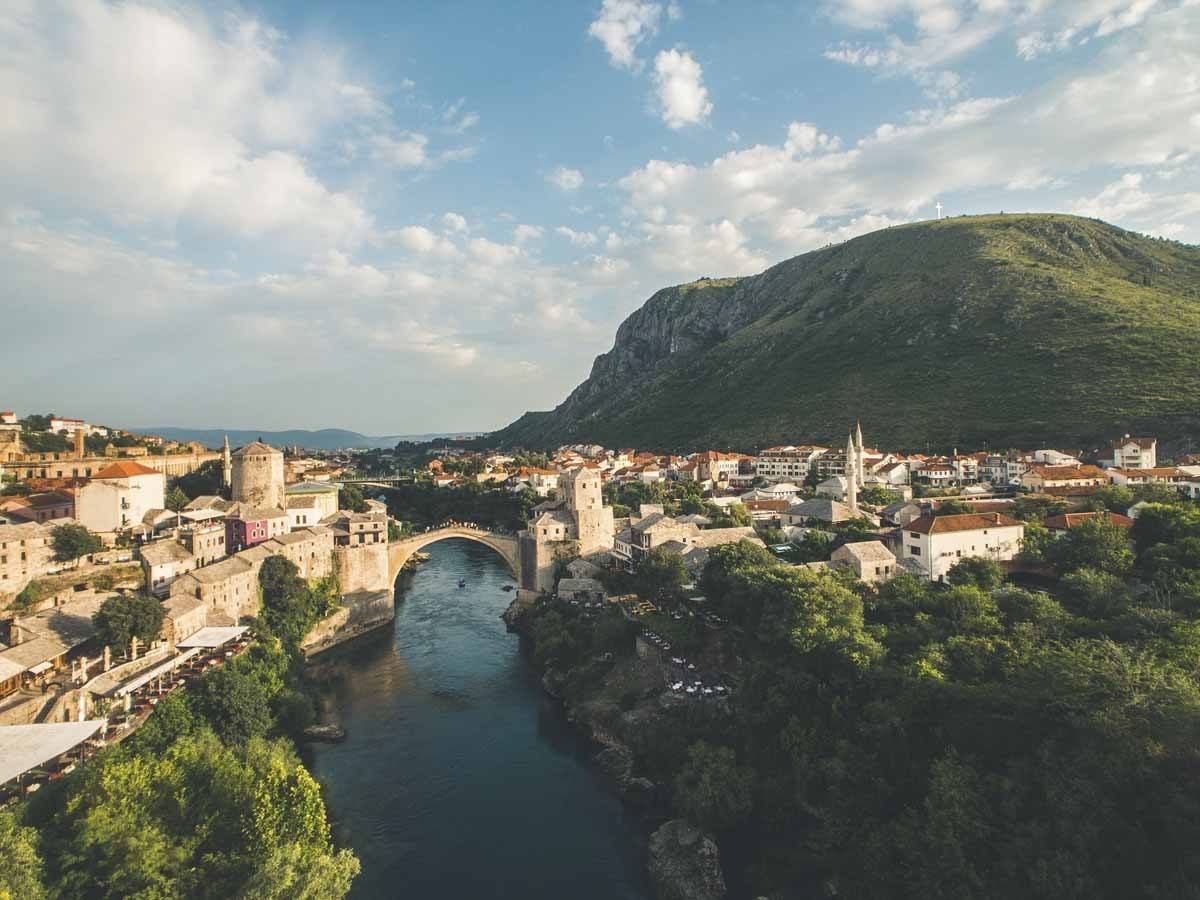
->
<box><xmin>0</xmin><ymin>0</ymin><xmax>386</xmax><ymax>250</ymax></box>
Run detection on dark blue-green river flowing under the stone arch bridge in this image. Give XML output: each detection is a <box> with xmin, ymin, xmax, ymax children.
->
<box><xmin>304</xmin><ymin>540</ymin><xmax>648</xmax><ymax>900</ymax></box>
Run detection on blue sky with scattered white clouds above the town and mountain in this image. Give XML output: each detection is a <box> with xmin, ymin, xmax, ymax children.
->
<box><xmin>0</xmin><ymin>0</ymin><xmax>1200</xmax><ymax>434</ymax></box>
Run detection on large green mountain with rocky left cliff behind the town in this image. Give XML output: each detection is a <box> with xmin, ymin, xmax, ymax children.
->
<box><xmin>488</xmin><ymin>215</ymin><xmax>1200</xmax><ymax>450</ymax></box>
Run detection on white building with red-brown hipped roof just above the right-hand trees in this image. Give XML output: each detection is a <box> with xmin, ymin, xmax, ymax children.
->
<box><xmin>902</xmin><ymin>512</ymin><xmax>1025</xmax><ymax>581</ymax></box>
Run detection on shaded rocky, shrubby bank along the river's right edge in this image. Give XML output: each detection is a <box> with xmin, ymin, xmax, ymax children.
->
<box><xmin>503</xmin><ymin>600</ymin><xmax>731</xmax><ymax>900</ymax></box>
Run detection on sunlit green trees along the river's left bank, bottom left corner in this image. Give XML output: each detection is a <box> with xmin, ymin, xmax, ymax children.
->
<box><xmin>7</xmin><ymin>558</ymin><xmax>359</xmax><ymax>900</ymax></box>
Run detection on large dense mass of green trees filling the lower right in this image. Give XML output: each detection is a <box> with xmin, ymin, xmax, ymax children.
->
<box><xmin>643</xmin><ymin>505</ymin><xmax>1200</xmax><ymax>898</ymax></box>
